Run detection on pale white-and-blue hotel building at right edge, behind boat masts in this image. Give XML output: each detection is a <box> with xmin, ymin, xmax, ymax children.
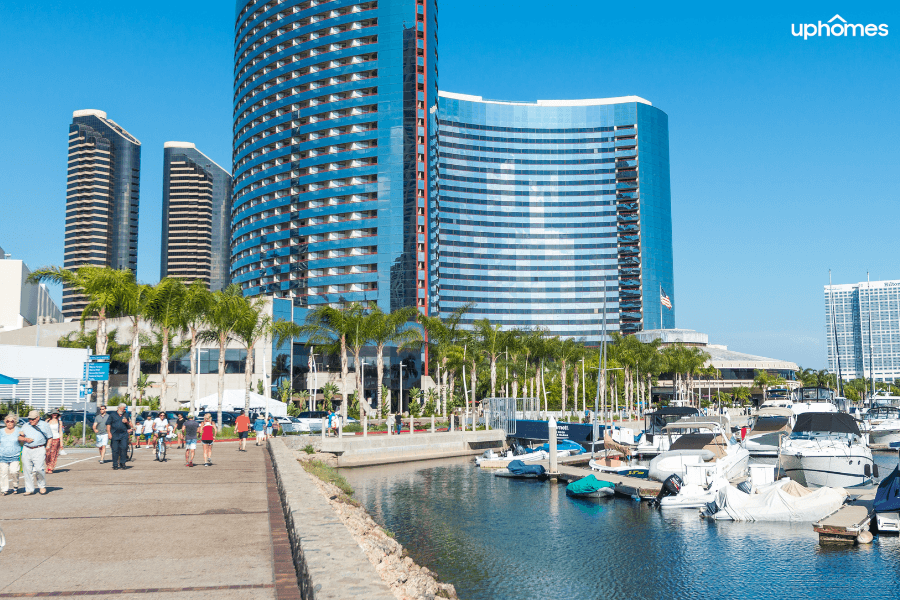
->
<box><xmin>825</xmin><ymin>281</ymin><xmax>900</xmax><ymax>381</ymax></box>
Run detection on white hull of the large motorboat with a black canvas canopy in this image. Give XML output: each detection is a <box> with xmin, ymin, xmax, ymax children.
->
<box><xmin>781</xmin><ymin>444</ymin><xmax>874</xmax><ymax>488</ymax></box>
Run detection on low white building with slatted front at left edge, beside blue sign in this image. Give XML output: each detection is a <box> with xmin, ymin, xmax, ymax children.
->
<box><xmin>0</xmin><ymin>346</ymin><xmax>89</xmax><ymax>412</ymax></box>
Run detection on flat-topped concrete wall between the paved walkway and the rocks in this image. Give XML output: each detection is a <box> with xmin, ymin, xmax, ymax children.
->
<box><xmin>268</xmin><ymin>438</ymin><xmax>395</xmax><ymax>600</ymax></box>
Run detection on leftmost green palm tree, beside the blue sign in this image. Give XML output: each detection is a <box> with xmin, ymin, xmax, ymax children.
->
<box><xmin>27</xmin><ymin>266</ymin><xmax>134</xmax><ymax>404</ymax></box>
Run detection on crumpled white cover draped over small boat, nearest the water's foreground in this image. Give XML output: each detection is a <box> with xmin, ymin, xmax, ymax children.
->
<box><xmin>712</xmin><ymin>480</ymin><xmax>847</xmax><ymax>522</ymax></box>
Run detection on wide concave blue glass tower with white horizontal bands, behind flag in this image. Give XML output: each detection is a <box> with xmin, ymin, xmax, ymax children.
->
<box><xmin>430</xmin><ymin>92</ymin><xmax>675</xmax><ymax>341</ymax></box>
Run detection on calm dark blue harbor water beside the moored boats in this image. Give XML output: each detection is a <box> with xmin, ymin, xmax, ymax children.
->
<box><xmin>343</xmin><ymin>454</ymin><xmax>900</xmax><ymax>600</ymax></box>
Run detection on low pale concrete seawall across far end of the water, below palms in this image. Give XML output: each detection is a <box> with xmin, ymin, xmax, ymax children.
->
<box><xmin>308</xmin><ymin>430</ymin><xmax>506</xmax><ymax>467</ymax></box>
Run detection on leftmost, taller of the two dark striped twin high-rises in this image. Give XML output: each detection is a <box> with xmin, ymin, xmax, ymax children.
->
<box><xmin>63</xmin><ymin>110</ymin><xmax>141</xmax><ymax>319</ymax></box>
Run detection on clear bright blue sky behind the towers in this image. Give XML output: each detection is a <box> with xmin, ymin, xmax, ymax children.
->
<box><xmin>0</xmin><ymin>0</ymin><xmax>900</xmax><ymax>368</ymax></box>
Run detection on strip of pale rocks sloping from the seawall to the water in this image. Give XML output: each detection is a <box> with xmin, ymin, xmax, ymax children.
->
<box><xmin>299</xmin><ymin>455</ymin><xmax>457</xmax><ymax>600</ymax></box>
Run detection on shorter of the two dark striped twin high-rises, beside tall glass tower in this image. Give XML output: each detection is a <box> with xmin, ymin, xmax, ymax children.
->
<box><xmin>160</xmin><ymin>142</ymin><xmax>231</xmax><ymax>291</ymax></box>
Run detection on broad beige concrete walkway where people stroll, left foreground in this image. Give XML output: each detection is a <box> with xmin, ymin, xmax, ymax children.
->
<box><xmin>0</xmin><ymin>443</ymin><xmax>299</xmax><ymax>600</ymax></box>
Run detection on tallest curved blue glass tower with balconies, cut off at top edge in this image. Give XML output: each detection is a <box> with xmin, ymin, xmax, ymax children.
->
<box><xmin>231</xmin><ymin>0</ymin><xmax>437</xmax><ymax>311</ymax></box>
